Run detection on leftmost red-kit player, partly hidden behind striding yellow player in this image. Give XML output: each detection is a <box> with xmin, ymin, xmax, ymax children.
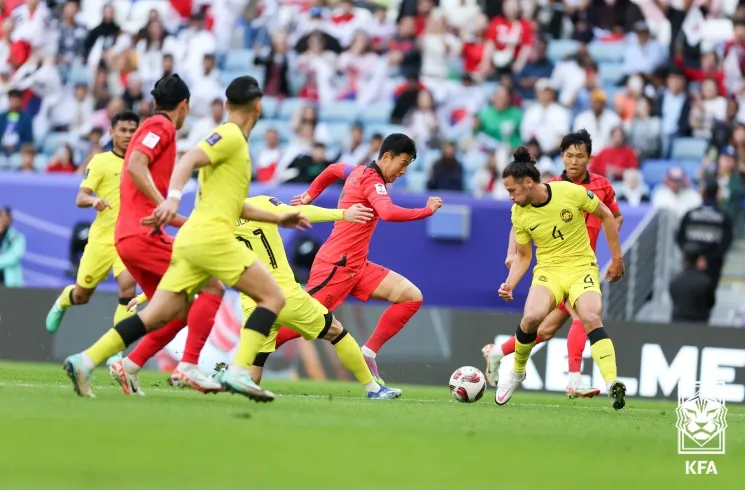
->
<box><xmin>109</xmin><ymin>75</ymin><xmax>224</xmax><ymax>395</ymax></box>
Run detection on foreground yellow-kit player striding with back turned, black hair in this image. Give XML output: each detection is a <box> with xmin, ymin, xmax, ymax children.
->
<box><xmin>65</xmin><ymin>76</ymin><xmax>310</xmax><ymax>401</ymax></box>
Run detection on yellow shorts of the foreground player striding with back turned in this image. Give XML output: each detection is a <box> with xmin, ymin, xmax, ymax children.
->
<box><xmin>158</xmin><ymin>233</ymin><xmax>257</xmax><ymax>298</ymax></box>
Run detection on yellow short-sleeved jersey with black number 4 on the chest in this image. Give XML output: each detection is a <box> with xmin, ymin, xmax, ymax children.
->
<box><xmin>512</xmin><ymin>182</ymin><xmax>600</xmax><ymax>268</ymax></box>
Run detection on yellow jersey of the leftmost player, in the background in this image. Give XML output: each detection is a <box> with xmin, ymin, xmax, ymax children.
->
<box><xmin>80</xmin><ymin>151</ymin><xmax>124</xmax><ymax>245</ymax></box>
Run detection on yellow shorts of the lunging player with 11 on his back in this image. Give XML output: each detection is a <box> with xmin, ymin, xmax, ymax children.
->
<box><xmin>241</xmin><ymin>290</ymin><xmax>329</xmax><ymax>352</ymax></box>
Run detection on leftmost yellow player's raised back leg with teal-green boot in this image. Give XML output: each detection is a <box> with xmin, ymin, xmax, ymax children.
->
<box><xmin>46</xmin><ymin>243</ymin><xmax>116</xmax><ymax>333</ymax></box>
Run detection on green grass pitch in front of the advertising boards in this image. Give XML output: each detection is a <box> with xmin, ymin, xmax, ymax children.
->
<box><xmin>0</xmin><ymin>363</ymin><xmax>745</xmax><ymax>490</ymax></box>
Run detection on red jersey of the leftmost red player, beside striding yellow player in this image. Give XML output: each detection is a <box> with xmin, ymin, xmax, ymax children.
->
<box><xmin>114</xmin><ymin>114</ymin><xmax>176</xmax><ymax>242</ymax></box>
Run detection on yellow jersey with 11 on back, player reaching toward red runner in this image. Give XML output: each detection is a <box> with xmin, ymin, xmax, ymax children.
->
<box><xmin>235</xmin><ymin>196</ymin><xmax>344</xmax><ymax>296</ymax></box>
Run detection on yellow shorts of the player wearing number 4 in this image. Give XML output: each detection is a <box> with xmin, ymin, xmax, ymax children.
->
<box><xmin>531</xmin><ymin>266</ymin><xmax>602</xmax><ymax>308</ymax></box>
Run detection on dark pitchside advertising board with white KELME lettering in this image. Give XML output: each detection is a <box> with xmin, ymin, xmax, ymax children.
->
<box><xmin>0</xmin><ymin>289</ymin><xmax>745</xmax><ymax>403</ymax></box>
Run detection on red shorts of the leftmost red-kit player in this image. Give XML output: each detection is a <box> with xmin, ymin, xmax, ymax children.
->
<box><xmin>116</xmin><ymin>233</ymin><xmax>173</xmax><ymax>300</ymax></box>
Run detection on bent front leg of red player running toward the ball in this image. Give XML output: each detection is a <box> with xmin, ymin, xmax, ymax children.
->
<box><xmin>352</xmin><ymin>262</ymin><xmax>423</xmax><ymax>384</ymax></box>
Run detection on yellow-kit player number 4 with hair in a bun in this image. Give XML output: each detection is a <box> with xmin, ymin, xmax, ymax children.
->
<box><xmin>494</xmin><ymin>146</ymin><xmax>626</xmax><ymax>410</ymax></box>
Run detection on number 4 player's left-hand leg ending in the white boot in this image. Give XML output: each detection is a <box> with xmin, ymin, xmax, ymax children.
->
<box><xmin>494</xmin><ymin>270</ymin><xmax>564</xmax><ymax>405</ymax></box>
